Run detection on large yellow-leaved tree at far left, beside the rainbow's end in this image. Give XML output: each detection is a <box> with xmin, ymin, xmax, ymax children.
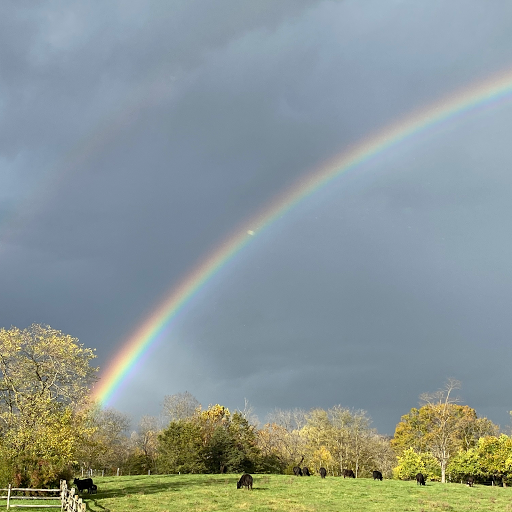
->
<box><xmin>0</xmin><ymin>324</ymin><xmax>97</xmax><ymax>486</ymax></box>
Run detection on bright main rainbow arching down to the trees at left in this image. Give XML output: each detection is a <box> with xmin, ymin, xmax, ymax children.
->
<box><xmin>93</xmin><ymin>71</ymin><xmax>512</xmax><ymax>406</ymax></box>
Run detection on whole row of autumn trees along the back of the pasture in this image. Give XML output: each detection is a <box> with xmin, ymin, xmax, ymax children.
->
<box><xmin>0</xmin><ymin>324</ymin><xmax>512</xmax><ymax>487</ymax></box>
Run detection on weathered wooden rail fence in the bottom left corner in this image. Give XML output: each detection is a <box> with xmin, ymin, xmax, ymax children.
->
<box><xmin>0</xmin><ymin>480</ymin><xmax>87</xmax><ymax>512</ymax></box>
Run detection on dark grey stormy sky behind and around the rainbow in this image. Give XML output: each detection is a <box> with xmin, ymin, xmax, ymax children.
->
<box><xmin>0</xmin><ymin>0</ymin><xmax>512</xmax><ymax>434</ymax></box>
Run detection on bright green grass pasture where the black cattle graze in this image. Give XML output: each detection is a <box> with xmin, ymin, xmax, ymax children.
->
<box><xmin>77</xmin><ymin>474</ymin><xmax>512</xmax><ymax>512</ymax></box>
